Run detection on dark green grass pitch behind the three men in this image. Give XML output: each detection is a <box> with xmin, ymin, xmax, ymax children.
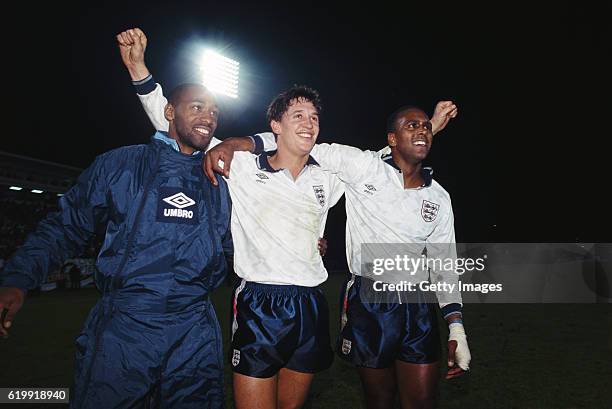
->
<box><xmin>0</xmin><ymin>276</ymin><xmax>612</xmax><ymax>409</ymax></box>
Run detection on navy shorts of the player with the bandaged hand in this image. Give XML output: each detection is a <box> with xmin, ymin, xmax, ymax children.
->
<box><xmin>337</xmin><ymin>276</ymin><xmax>441</xmax><ymax>368</ymax></box>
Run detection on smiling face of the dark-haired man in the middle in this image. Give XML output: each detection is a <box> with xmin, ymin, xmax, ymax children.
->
<box><xmin>270</xmin><ymin>98</ymin><xmax>319</xmax><ymax>156</ymax></box>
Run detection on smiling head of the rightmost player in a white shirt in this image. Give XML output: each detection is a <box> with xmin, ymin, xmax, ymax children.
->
<box><xmin>387</xmin><ymin>108</ymin><xmax>433</xmax><ymax>163</ymax></box>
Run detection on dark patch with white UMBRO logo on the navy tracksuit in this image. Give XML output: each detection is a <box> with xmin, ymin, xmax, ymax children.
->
<box><xmin>157</xmin><ymin>187</ymin><xmax>198</xmax><ymax>224</ymax></box>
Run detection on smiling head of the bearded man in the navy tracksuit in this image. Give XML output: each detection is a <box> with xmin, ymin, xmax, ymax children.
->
<box><xmin>165</xmin><ymin>84</ymin><xmax>219</xmax><ymax>154</ymax></box>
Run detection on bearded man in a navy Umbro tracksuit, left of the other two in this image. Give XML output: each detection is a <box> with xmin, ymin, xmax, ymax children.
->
<box><xmin>0</xmin><ymin>84</ymin><xmax>231</xmax><ymax>409</ymax></box>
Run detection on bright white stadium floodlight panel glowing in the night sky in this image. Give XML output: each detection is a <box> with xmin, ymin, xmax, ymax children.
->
<box><xmin>200</xmin><ymin>50</ymin><xmax>240</xmax><ymax>98</ymax></box>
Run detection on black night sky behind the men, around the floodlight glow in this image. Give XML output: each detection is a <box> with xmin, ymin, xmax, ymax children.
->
<box><xmin>0</xmin><ymin>1</ymin><xmax>612</xmax><ymax>252</ymax></box>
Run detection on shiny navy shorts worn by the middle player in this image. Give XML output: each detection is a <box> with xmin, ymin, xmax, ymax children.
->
<box><xmin>230</xmin><ymin>280</ymin><xmax>333</xmax><ymax>378</ymax></box>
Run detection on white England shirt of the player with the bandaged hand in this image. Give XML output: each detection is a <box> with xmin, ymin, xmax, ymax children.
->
<box><xmin>256</xmin><ymin>133</ymin><xmax>461</xmax><ymax>307</ymax></box>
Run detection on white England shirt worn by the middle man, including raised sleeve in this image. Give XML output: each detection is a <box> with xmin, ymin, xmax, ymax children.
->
<box><xmin>139</xmin><ymin>84</ymin><xmax>344</xmax><ymax>287</ymax></box>
